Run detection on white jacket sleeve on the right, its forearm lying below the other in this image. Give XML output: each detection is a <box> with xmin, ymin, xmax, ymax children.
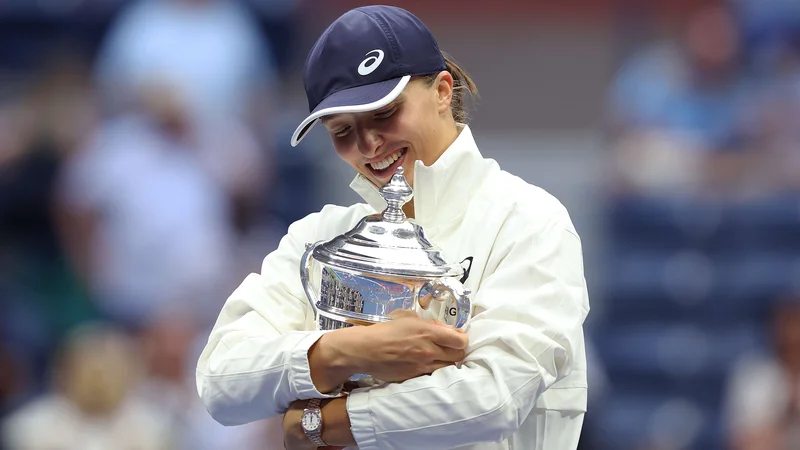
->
<box><xmin>347</xmin><ymin>216</ymin><xmax>589</xmax><ymax>450</ymax></box>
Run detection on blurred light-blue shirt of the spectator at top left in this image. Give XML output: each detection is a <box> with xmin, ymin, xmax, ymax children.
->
<box><xmin>97</xmin><ymin>0</ymin><xmax>277</xmax><ymax>126</ymax></box>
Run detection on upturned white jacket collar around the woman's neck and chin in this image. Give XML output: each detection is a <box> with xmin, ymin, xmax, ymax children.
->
<box><xmin>350</xmin><ymin>125</ymin><xmax>497</xmax><ymax>231</ymax></box>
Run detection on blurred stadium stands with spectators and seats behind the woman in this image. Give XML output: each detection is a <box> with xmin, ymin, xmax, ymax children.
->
<box><xmin>0</xmin><ymin>0</ymin><xmax>800</xmax><ymax>450</ymax></box>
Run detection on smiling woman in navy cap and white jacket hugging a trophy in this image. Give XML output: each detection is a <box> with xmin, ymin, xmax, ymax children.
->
<box><xmin>197</xmin><ymin>6</ymin><xmax>589</xmax><ymax>450</ymax></box>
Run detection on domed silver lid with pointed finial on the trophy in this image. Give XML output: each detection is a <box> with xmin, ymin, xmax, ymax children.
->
<box><xmin>313</xmin><ymin>167</ymin><xmax>464</xmax><ymax>278</ymax></box>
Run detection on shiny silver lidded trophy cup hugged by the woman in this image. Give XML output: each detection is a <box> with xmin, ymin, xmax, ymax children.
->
<box><xmin>300</xmin><ymin>167</ymin><xmax>472</xmax><ymax>352</ymax></box>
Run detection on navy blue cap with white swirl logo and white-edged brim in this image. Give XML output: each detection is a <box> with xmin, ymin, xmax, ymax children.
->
<box><xmin>291</xmin><ymin>6</ymin><xmax>447</xmax><ymax>146</ymax></box>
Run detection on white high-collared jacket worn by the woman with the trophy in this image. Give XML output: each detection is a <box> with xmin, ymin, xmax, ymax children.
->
<box><xmin>197</xmin><ymin>126</ymin><xmax>589</xmax><ymax>450</ymax></box>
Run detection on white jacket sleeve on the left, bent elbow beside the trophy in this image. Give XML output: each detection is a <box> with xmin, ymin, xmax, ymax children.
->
<box><xmin>196</xmin><ymin>209</ymin><xmax>344</xmax><ymax>425</ymax></box>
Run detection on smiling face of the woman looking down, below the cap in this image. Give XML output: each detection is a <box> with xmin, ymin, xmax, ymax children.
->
<box><xmin>323</xmin><ymin>72</ymin><xmax>457</xmax><ymax>187</ymax></box>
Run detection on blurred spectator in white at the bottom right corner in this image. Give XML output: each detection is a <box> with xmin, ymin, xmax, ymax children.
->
<box><xmin>725</xmin><ymin>295</ymin><xmax>800</xmax><ymax>450</ymax></box>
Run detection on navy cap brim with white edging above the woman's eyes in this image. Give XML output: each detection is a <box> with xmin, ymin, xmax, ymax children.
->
<box><xmin>291</xmin><ymin>75</ymin><xmax>411</xmax><ymax>147</ymax></box>
